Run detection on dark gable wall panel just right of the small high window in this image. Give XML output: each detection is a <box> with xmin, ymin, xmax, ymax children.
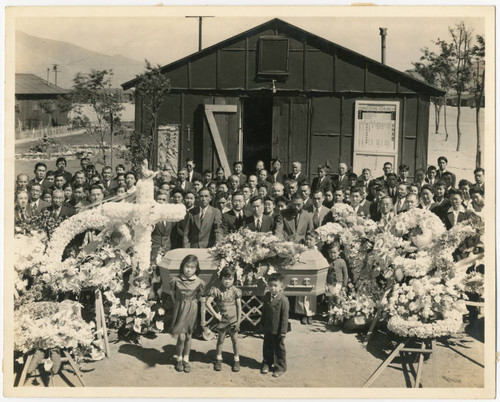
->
<box><xmin>306</xmin><ymin>51</ymin><xmax>333</xmax><ymax>91</ymax></box>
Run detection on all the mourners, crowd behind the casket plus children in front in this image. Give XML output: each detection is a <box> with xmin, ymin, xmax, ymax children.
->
<box><xmin>15</xmin><ymin>156</ymin><xmax>485</xmax><ymax>373</ymax></box>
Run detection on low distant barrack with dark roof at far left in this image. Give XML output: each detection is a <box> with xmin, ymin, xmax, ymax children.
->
<box><xmin>16</xmin><ymin>74</ymin><xmax>70</xmax><ymax>130</ymax></box>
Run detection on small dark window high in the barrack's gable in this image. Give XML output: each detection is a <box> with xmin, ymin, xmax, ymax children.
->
<box><xmin>258</xmin><ymin>36</ymin><xmax>289</xmax><ymax>77</ymax></box>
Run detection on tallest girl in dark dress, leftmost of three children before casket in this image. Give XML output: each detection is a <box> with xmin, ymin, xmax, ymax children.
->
<box><xmin>170</xmin><ymin>254</ymin><xmax>205</xmax><ymax>373</ymax></box>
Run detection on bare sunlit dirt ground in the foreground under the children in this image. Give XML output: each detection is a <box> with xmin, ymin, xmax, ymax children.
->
<box><xmin>26</xmin><ymin>318</ymin><xmax>484</xmax><ymax>388</ymax></box>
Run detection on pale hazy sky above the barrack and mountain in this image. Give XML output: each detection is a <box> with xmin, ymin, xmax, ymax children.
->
<box><xmin>15</xmin><ymin>15</ymin><xmax>484</xmax><ymax>70</ymax></box>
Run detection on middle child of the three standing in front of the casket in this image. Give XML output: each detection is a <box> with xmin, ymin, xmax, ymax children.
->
<box><xmin>206</xmin><ymin>267</ymin><xmax>241</xmax><ymax>372</ymax></box>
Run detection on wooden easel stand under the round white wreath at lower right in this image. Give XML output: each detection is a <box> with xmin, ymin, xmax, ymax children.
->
<box><xmin>362</xmin><ymin>338</ymin><xmax>436</xmax><ymax>388</ymax></box>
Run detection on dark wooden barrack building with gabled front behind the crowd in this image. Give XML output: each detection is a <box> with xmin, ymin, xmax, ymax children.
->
<box><xmin>122</xmin><ymin>19</ymin><xmax>444</xmax><ymax>178</ymax></box>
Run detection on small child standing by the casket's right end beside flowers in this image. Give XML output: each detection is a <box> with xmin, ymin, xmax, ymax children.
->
<box><xmin>326</xmin><ymin>241</ymin><xmax>349</xmax><ymax>324</ymax></box>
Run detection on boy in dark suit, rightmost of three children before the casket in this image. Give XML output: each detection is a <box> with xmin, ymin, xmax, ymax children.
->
<box><xmin>260</xmin><ymin>273</ymin><xmax>290</xmax><ymax>377</ymax></box>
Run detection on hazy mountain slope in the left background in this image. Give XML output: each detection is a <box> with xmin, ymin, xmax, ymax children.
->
<box><xmin>16</xmin><ymin>31</ymin><xmax>144</xmax><ymax>88</ymax></box>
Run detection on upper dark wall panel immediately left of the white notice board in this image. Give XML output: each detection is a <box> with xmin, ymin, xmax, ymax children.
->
<box><xmin>311</xmin><ymin>96</ymin><xmax>341</xmax><ymax>135</ymax></box>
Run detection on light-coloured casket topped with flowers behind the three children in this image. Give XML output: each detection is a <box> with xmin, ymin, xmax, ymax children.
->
<box><xmin>158</xmin><ymin>248</ymin><xmax>328</xmax><ymax>296</ymax></box>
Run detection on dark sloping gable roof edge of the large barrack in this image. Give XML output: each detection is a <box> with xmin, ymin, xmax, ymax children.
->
<box><xmin>121</xmin><ymin>18</ymin><xmax>446</xmax><ymax>96</ymax></box>
